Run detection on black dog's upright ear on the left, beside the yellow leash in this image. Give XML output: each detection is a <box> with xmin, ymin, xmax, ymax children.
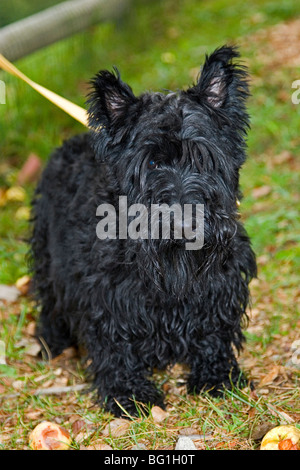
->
<box><xmin>87</xmin><ymin>68</ymin><xmax>138</xmax><ymax>130</ymax></box>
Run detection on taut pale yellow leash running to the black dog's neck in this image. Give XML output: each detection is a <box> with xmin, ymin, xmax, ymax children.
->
<box><xmin>0</xmin><ymin>54</ymin><xmax>88</xmax><ymax>127</ymax></box>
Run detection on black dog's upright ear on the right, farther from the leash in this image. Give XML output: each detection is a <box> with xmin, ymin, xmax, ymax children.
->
<box><xmin>186</xmin><ymin>46</ymin><xmax>249</xmax><ymax>129</ymax></box>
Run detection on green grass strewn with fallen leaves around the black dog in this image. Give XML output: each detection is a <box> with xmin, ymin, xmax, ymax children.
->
<box><xmin>0</xmin><ymin>0</ymin><xmax>300</xmax><ymax>450</ymax></box>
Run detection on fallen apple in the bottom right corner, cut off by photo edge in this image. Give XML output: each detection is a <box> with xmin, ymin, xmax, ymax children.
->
<box><xmin>260</xmin><ymin>424</ymin><xmax>300</xmax><ymax>450</ymax></box>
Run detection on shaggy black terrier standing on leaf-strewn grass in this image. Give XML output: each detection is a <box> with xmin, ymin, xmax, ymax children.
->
<box><xmin>32</xmin><ymin>46</ymin><xmax>256</xmax><ymax>415</ymax></box>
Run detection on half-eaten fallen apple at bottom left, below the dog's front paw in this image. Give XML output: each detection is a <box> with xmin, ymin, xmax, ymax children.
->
<box><xmin>29</xmin><ymin>421</ymin><xmax>71</xmax><ymax>450</ymax></box>
